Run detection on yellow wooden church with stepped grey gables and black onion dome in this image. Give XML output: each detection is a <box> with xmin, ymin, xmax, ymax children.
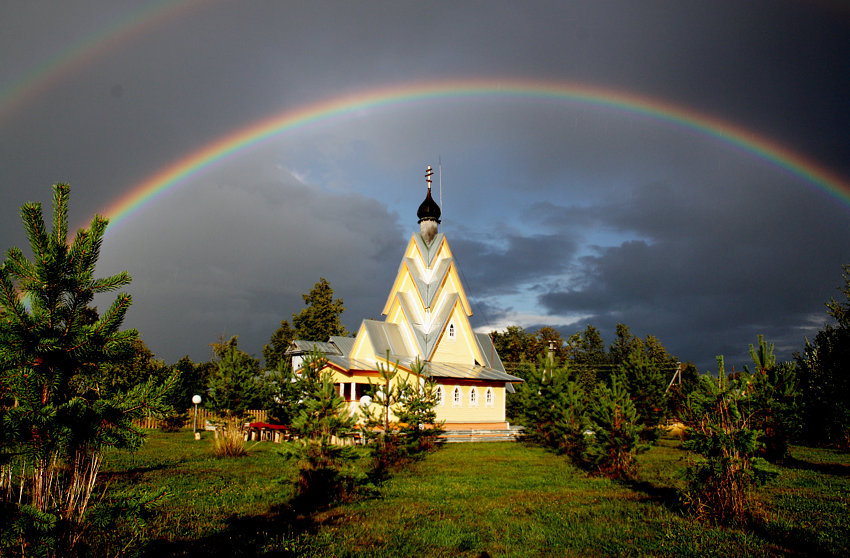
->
<box><xmin>288</xmin><ymin>166</ymin><xmax>522</xmax><ymax>431</ymax></box>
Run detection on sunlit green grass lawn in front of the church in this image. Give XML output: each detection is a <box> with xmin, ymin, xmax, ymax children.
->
<box><xmin>92</xmin><ymin>432</ymin><xmax>850</xmax><ymax>556</ymax></box>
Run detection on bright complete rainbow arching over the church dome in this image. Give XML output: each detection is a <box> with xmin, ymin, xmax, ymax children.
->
<box><xmin>104</xmin><ymin>79</ymin><xmax>850</xmax><ymax>226</ymax></box>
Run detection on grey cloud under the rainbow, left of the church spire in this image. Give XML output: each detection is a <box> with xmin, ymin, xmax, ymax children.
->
<box><xmin>99</xmin><ymin>156</ymin><xmax>404</xmax><ymax>359</ymax></box>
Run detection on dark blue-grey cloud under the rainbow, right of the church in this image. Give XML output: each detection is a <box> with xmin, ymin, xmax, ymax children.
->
<box><xmin>538</xmin><ymin>168</ymin><xmax>847</xmax><ymax>367</ymax></box>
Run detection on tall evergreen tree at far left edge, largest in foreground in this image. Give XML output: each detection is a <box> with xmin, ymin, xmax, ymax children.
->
<box><xmin>0</xmin><ymin>184</ymin><xmax>172</xmax><ymax>554</ymax></box>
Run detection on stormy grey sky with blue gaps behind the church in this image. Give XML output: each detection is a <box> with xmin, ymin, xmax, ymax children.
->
<box><xmin>0</xmin><ymin>0</ymin><xmax>850</xmax><ymax>371</ymax></box>
